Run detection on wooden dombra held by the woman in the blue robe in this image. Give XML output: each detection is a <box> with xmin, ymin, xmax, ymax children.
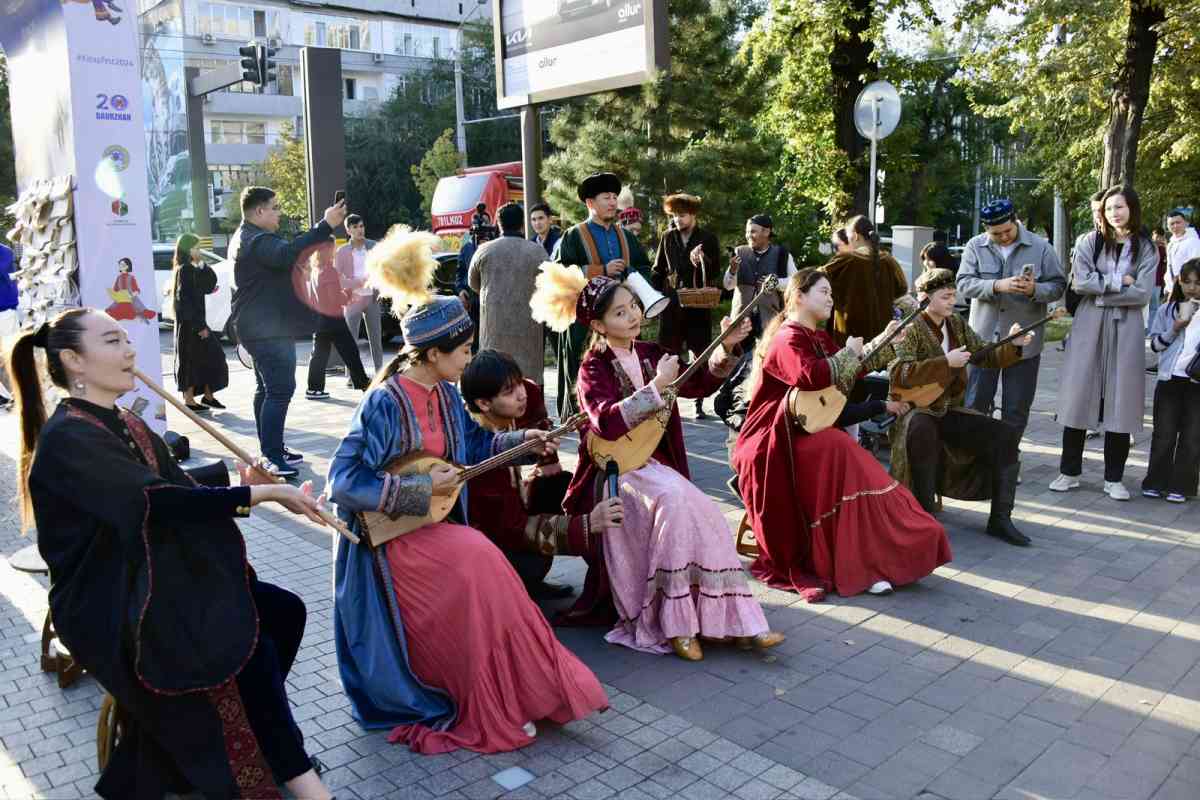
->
<box><xmin>358</xmin><ymin>414</ymin><xmax>588</xmax><ymax>547</ymax></box>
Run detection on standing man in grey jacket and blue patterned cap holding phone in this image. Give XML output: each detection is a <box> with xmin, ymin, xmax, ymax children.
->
<box><xmin>958</xmin><ymin>199</ymin><xmax>1067</xmax><ymax>435</ymax></box>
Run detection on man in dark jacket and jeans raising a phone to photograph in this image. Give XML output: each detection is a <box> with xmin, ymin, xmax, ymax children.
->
<box><xmin>229</xmin><ymin>186</ymin><xmax>346</xmax><ymax>477</ymax></box>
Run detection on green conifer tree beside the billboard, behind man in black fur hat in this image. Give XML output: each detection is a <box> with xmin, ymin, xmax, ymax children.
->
<box><xmin>545</xmin><ymin>0</ymin><xmax>794</xmax><ymax>251</ymax></box>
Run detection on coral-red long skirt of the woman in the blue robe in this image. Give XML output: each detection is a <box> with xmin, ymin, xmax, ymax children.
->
<box><xmin>388</xmin><ymin>523</ymin><xmax>608</xmax><ymax>753</ymax></box>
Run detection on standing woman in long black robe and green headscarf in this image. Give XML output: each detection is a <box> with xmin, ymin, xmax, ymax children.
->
<box><xmin>172</xmin><ymin>234</ymin><xmax>229</xmax><ymax>411</ymax></box>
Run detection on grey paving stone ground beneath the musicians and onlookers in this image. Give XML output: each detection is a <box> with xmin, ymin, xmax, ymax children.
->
<box><xmin>0</xmin><ymin>336</ymin><xmax>1200</xmax><ymax>800</ymax></box>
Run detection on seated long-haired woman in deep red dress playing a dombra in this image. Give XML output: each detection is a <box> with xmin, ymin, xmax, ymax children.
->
<box><xmin>733</xmin><ymin>269</ymin><xmax>950</xmax><ymax>602</ymax></box>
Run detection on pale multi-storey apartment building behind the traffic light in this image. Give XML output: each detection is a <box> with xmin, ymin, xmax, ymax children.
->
<box><xmin>139</xmin><ymin>0</ymin><xmax>492</xmax><ymax>236</ymax></box>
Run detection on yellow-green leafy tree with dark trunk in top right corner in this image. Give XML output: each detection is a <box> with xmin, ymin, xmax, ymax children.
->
<box><xmin>961</xmin><ymin>0</ymin><xmax>1200</xmax><ymax>224</ymax></box>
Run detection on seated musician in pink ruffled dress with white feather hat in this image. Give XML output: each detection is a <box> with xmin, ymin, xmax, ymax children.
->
<box><xmin>529</xmin><ymin>263</ymin><xmax>784</xmax><ymax>661</ymax></box>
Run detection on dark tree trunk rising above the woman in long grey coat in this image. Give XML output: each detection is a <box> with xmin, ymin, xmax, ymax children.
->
<box><xmin>1100</xmin><ymin>0</ymin><xmax>1166</xmax><ymax>190</ymax></box>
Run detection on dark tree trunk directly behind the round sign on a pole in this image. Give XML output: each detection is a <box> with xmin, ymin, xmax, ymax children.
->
<box><xmin>829</xmin><ymin>0</ymin><xmax>878</xmax><ymax>216</ymax></box>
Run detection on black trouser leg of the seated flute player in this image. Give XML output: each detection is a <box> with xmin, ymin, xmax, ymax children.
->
<box><xmin>238</xmin><ymin>578</ymin><xmax>312</xmax><ymax>783</ymax></box>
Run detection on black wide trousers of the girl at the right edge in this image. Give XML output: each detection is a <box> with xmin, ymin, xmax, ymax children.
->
<box><xmin>1141</xmin><ymin>378</ymin><xmax>1200</xmax><ymax>497</ymax></box>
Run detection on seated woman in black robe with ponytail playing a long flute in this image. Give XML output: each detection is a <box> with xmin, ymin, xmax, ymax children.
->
<box><xmin>8</xmin><ymin>308</ymin><xmax>330</xmax><ymax>800</ymax></box>
